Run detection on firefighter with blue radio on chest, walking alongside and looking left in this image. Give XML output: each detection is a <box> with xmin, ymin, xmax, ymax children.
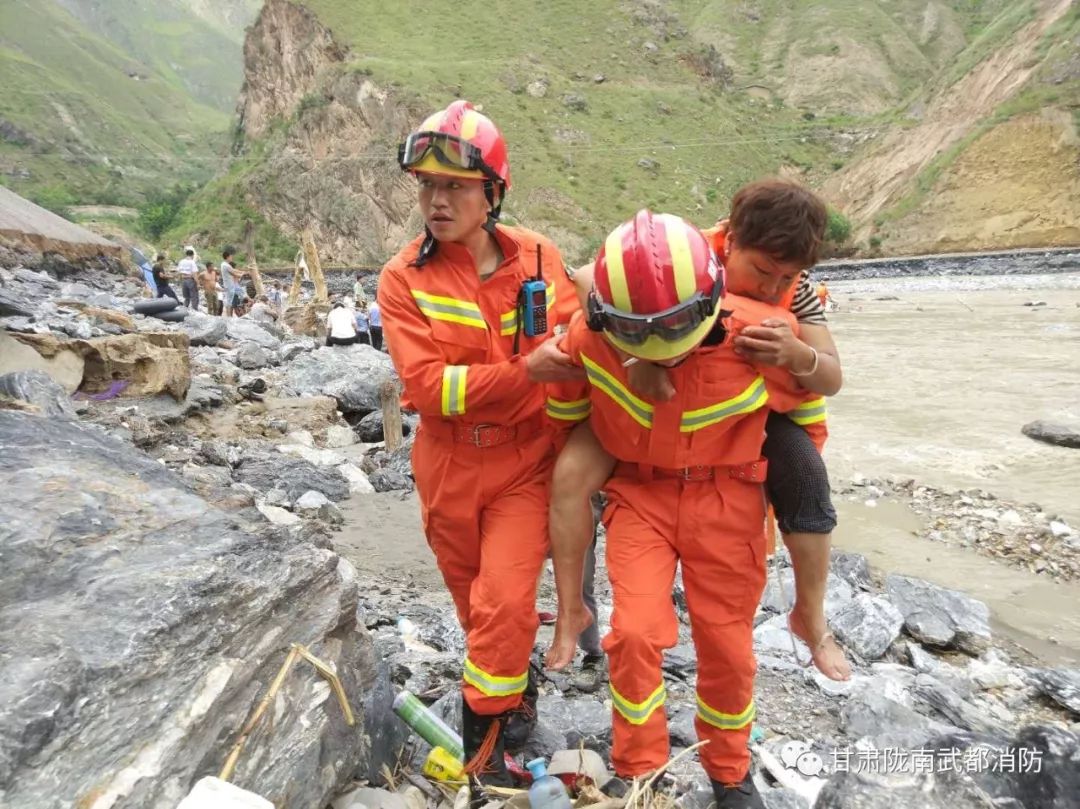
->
<box><xmin>378</xmin><ymin>100</ymin><xmax>582</xmax><ymax>797</ymax></box>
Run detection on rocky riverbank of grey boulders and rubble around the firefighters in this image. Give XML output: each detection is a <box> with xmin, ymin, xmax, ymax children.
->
<box><xmin>0</xmin><ymin>253</ymin><xmax>1080</xmax><ymax>809</ymax></box>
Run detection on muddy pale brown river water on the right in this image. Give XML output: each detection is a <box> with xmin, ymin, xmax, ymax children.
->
<box><xmin>826</xmin><ymin>273</ymin><xmax>1080</xmax><ymax>664</ymax></box>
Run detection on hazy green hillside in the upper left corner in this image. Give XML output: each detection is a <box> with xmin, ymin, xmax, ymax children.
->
<box><xmin>0</xmin><ymin>0</ymin><xmax>229</xmax><ymax>204</ymax></box>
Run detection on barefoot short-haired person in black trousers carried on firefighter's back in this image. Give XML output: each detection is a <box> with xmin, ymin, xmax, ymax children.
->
<box><xmin>548</xmin><ymin>179</ymin><xmax>851</xmax><ymax>680</ymax></box>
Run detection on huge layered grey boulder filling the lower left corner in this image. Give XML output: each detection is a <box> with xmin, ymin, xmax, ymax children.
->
<box><xmin>0</xmin><ymin>412</ymin><xmax>376</xmax><ymax>809</ymax></box>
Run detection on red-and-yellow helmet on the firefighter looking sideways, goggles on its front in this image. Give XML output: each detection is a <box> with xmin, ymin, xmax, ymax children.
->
<box><xmin>397</xmin><ymin>100</ymin><xmax>510</xmax><ymax>193</ymax></box>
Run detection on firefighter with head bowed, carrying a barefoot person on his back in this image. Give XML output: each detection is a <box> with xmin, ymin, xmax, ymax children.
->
<box><xmin>548</xmin><ymin>211</ymin><xmax>805</xmax><ymax>808</ymax></box>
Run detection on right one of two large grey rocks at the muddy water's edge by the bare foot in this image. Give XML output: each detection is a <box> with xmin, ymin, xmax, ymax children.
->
<box><xmin>886</xmin><ymin>576</ymin><xmax>990</xmax><ymax>655</ymax></box>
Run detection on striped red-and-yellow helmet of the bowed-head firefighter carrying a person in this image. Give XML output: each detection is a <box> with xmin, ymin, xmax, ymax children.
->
<box><xmin>589</xmin><ymin>210</ymin><xmax>724</xmax><ymax>361</ymax></box>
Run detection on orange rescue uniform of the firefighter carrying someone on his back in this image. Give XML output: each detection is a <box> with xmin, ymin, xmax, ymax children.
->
<box><xmin>548</xmin><ymin>295</ymin><xmax>802</xmax><ymax>783</ymax></box>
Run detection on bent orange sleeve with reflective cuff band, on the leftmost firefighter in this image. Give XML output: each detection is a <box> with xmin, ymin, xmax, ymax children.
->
<box><xmin>378</xmin><ymin>266</ymin><xmax>536</xmax><ymax>423</ymax></box>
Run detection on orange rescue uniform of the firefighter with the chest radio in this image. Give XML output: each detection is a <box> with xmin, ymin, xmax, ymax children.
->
<box><xmin>378</xmin><ymin>225</ymin><xmax>577</xmax><ymax>715</ymax></box>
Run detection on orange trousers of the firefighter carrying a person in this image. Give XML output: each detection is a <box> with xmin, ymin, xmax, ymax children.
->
<box><xmin>604</xmin><ymin>466</ymin><xmax>765</xmax><ymax>783</ymax></box>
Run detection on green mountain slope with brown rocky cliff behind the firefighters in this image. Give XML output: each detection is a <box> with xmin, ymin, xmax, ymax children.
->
<box><xmin>173</xmin><ymin>0</ymin><xmax>1076</xmax><ymax>264</ymax></box>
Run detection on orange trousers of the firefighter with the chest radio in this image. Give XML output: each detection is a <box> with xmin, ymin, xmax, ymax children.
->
<box><xmin>413</xmin><ymin>422</ymin><xmax>554</xmax><ymax>715</ymax></box>
